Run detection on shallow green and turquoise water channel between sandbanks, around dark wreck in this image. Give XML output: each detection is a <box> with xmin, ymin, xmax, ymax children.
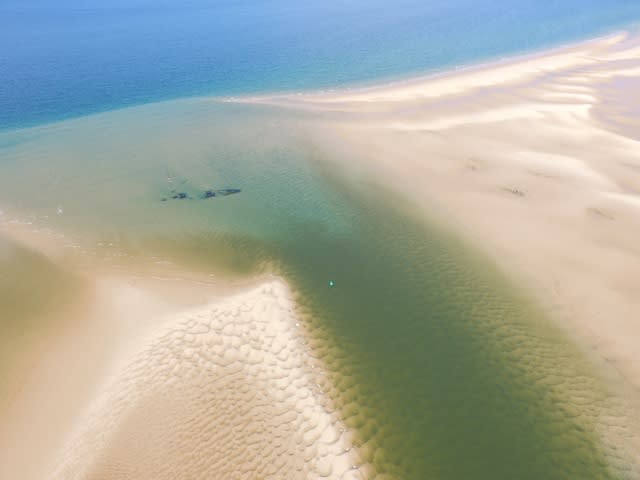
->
<box><xmin>0</xmin><ymin>101</ymin><xmax>615</xmax><ymax>480</ymax></box>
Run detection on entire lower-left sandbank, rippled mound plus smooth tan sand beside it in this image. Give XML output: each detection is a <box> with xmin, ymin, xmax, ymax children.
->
<box><xmin>0</xmin><ymin>224</ymin><xmax>366</xmax><ymax>480</ymax></box>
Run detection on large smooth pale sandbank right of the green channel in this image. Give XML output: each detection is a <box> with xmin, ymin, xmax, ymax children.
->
<box><xmin>249</xmin><ymin>33</ymin><xmax>640</xmax><ymax>402</ymax></box>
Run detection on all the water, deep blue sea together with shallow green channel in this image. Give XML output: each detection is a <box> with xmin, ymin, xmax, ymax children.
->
<box><xmin>0</xmin><ymin>0</ymin><xmax>640</xmax><ymax>480</ymax></box>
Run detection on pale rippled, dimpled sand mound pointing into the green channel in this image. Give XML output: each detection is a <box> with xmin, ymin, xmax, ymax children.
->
<box><xmin>51</xmin><ymin>281</ymin><xmax>363</xmax><ymax>480</ymax></box>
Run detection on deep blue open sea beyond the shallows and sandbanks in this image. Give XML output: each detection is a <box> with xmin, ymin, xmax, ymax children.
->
<box><xmin>0</xmin><ymin>0</ymin><xmax>640</xmax><ymax>129</ymax></box>
